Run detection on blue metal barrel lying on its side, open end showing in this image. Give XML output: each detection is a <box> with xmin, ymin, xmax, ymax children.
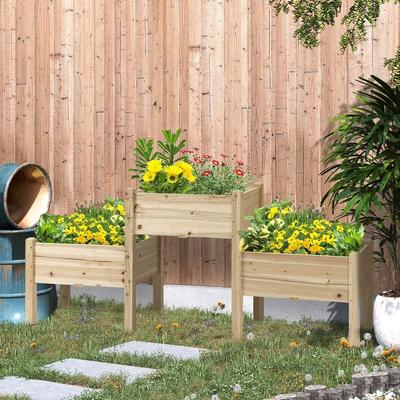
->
<box><xmin>0</xmin><ymin>163</ymin><xmax>51</xmax><ymax>229</ymax></box>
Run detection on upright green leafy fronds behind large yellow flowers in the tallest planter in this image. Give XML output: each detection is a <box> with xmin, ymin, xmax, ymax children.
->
<box><xmin>129</xmin><ymin>129</ymin><xmax>186</xmax><ymax>179</ymax></box>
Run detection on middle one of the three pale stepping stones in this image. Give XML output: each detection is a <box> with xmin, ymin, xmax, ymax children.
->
<box><xmin>43</xmin><ymin>358</ymin><xmax>156</xmax><ymax>384</ymax></box>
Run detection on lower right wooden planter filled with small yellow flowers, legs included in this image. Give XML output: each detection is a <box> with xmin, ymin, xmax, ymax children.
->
<box><xmin>232</xmin><ymin>201</ymin><xmax>372</xmax><ymax>345</ymax></box>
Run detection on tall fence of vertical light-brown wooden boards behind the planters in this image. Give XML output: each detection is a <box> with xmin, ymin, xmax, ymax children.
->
<box><xmin>0</xmin><ymin>0</ymin><xmax>400</xmax><ymax>285</ymax></box>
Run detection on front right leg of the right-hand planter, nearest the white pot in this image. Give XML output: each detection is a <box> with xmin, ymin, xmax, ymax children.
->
<box><xmin>349</xmin><ymin>252</ymin><xmax>361</xmax><ymax>347</ymax></box>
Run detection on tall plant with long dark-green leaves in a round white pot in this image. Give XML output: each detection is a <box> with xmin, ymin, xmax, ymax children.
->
<box><xmin>322</xmin><ymin>76</ymin><xmax>400</xmax><ymax>349</ymax></box>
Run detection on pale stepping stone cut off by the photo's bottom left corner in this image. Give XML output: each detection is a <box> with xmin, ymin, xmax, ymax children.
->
<box><xmin>0</xmin><ymin>376</ymin><xmax>94</xmax><ymax>400</ymax></box>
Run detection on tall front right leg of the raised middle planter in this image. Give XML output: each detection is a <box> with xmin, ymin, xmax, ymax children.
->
<box><xmin>231</xmin><ymin>191</ymin><xmax>243</xmax><ymax>340</ymax></box>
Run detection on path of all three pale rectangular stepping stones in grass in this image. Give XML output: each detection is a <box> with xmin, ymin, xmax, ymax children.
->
<box><xmin>0</xmin><ymin>341</ymin><xmax>207</xmax><ymax>400</ymax></box>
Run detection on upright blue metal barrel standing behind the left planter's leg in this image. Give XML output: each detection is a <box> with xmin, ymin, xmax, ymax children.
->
<box><xmin>0</xmin><ymin>229</ymin><xmax>57</xmax><ymax>323</ymax></box>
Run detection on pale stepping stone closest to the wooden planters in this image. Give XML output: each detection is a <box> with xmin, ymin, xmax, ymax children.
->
<box><xmin>101</xmin><ymin>341</ymin><xmax>207</xmax><ymax>360</ymax></box>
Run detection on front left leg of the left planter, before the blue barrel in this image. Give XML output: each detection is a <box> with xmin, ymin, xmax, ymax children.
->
<box><xmin>25</xmin><ymin>238</ymin><xmax>37</xmax><ymax>324</ymax></box>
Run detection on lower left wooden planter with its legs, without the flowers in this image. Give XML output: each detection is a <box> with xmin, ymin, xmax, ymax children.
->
<box><xmin>25</xmin><ymin>192</ymin><xmax>163</xmax><ymax>330</ymax></box>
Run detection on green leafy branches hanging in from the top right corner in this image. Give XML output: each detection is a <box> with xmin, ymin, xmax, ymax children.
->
<box><xmin>269</xmin><ymin>0</ymin><xmax>400</xmax><ymax>81</ymax></box>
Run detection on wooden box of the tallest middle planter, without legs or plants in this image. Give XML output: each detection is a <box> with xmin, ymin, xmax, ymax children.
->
<box><xmin>134</xmin><ymin>184</ymin><xmax>262</xmax><ymax>239</ymax></box>
